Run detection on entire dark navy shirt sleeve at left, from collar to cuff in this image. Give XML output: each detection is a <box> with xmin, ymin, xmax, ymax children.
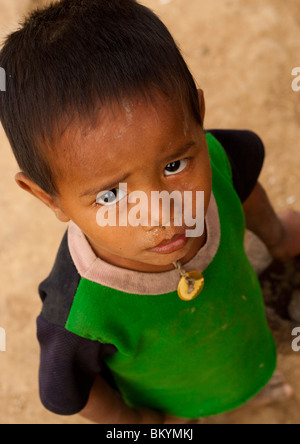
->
<box><xmin>37</xmin><ymin>232</ymin><xmax>117</xmax><ymax>415</ymax></box>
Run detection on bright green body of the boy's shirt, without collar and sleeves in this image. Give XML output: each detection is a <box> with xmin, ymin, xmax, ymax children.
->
<box><xmin>66</xmin><ymin>134</ymin><xmax>276</xmax><ymax>418</ymax></box>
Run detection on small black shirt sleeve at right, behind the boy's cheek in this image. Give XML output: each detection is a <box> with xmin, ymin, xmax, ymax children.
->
<box><xmin>208</xmin><ymin>130</ymin><xmax>265</xmax><ymax>203</ymax></box>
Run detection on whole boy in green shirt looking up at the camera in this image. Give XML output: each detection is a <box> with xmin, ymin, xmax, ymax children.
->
<box><xmin>0</xmin><ymin>0</ymin><xmax>300</xmax><ymax>424</ymax></box>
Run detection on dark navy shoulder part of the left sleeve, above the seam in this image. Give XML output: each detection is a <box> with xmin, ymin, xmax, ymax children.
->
<box><xmin>39</xmin><ymin>230</ymin><xmax>81</xmax><ymax>327</ymax></box>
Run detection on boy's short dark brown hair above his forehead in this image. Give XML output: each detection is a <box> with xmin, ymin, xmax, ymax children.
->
<box><xmin>0</xmin><ymin>0</ymin><xmax>202</xmax><ymax>195</ymax></box>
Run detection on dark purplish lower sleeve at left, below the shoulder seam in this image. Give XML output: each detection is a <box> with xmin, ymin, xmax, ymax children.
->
<box><xmin>37</xmin><ymin>316</ymin><xmax>114</xmax><ymax>415</ymax></box>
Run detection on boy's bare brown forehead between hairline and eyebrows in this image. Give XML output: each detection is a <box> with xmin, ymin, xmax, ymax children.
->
<box><xmin>53</xmin><ymin>95</ymin><xmax>195</xmax><ymax>186</ymax></box>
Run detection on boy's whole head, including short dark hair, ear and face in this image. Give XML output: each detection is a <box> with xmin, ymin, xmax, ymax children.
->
<box><xmin>0</xmin><ymin>0</ymin><xmax>211</xmax><ymax>271</ymax></box>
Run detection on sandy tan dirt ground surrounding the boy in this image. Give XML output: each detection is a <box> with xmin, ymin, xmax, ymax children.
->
<box><xmin>0</xmin><ymin>0</ymin><xmax>300</xmax><ymax>424</ymax></box>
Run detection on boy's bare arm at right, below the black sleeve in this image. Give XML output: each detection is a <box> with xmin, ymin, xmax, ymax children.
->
<box><xmin>243</xmin><ymin>183</ymin><xmax>300</xmax><ymax>260</ymax></box>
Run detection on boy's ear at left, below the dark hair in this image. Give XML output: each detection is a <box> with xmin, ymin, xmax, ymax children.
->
<box><xmin>15</xmin><ymin>172</ymin><xmax>70</xmax><ymax>222</ymax></box>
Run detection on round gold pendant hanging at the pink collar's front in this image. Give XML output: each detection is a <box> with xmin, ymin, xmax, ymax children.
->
<box><xmin>173</xmin><ymin>261</ymin><xmax>204</xmax><ymax>301</ymax></box>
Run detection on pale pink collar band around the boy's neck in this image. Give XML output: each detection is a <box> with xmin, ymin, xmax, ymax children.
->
<box><xmin>68</xmin><ymin>194</ymin><xmax>221</xmax><ymax>295</ymax></box>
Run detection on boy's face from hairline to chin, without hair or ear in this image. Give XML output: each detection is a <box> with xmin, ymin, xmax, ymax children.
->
<box><xmin>21</xmin><ymin>91</ymin><xmax>211</xmax><ymax>272</ymax></box>
